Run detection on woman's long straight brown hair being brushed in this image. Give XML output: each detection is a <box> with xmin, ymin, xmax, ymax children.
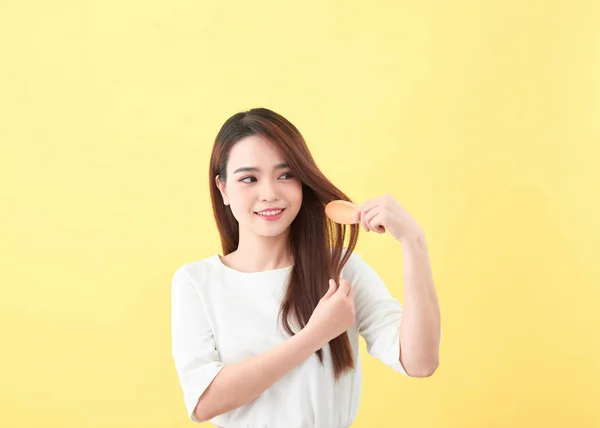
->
<box><xmin>209</xmin><ymin>108</ymin><xmax>359</xmax><ymax>379</ymax></box>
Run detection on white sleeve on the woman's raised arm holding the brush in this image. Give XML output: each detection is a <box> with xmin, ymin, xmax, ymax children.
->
<box><xmin>342</xmin><ymin>253</ymin><xmax>407</xmax><ymax>374</ymax></box>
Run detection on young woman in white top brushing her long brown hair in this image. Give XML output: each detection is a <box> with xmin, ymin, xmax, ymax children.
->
<box><xmin>172</xmin><ymin>109</ymin><xmax>440</xmax><ymax>428</ymax></box>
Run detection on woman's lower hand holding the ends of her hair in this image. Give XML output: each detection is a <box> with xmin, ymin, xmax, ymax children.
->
<box><xmin>306</xmin><ymin>278</ymin><xmax>355</xmax><ymax>343</ymax></box>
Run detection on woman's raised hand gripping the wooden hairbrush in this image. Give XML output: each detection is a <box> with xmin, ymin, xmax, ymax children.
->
<box><xmin>354</xmin><ymin>194</ymin><xmax>424</xmax><ymax>241</ymax></box>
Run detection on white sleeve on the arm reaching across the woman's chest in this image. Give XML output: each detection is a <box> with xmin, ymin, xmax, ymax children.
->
<box><xmin>171</xmin><ymin>267</ymin><xmax>224</xmax><ymax>422</ymax></box>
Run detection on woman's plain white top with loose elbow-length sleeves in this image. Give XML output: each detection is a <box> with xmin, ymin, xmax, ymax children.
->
<box><xmin>172</xmin><ymin>253</ymin><xmax>406</xmax><ymax>428</ymax></box>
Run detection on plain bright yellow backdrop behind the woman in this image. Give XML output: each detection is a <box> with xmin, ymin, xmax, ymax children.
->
<box><xmin>0</xmin><ymin>0</ymin><xmax>600</xmax><ymax>428</ymax></box>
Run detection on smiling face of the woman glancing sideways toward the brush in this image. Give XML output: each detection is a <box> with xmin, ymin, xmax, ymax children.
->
<box><xmin>216</xmin><ymin>135</ymin><xmax>302</xmax><ymax>237</ymax></box>
